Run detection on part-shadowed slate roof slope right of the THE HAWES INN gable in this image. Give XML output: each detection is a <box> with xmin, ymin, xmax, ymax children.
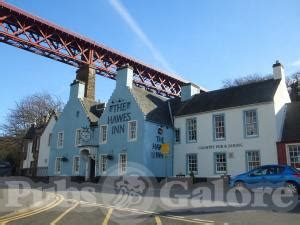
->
<box><xmin>131</xmin><ymin>87</ymin><xmax>172</xmax><ymax>125</ymax></box>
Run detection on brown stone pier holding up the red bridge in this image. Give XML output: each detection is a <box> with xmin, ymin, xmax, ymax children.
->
<box><xmin>76</xmin><ymin>65</ymin><xmax>96</xmax><ymax>101</ymax></box>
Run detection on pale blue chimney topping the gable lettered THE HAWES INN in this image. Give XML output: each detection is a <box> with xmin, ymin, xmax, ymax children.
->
<box><xmin>116</xmin><ymin>64</ymin><xmax>133</xmax><ymax>89</ymax></box>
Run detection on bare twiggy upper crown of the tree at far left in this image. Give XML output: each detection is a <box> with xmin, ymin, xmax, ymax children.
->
<box><xmin>0</xmin><ymin>93</ymin><xmax>64</xmax><ymax>137</ymax></box>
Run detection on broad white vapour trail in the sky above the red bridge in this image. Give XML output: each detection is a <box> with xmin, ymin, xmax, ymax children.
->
<box><xmin>109</xmin><ymin>0</ymin><xmax>175</xmax><ymax>73</ymax></box>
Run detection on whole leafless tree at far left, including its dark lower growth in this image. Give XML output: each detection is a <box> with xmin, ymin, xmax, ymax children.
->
<box><xmin>0</xmin><ymin>93</ymin><xmax>64</xmax><ymax>175</ymax></box>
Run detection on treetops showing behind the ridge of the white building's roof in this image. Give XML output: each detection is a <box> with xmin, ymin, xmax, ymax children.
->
<box><xmin>222</xmin><ymin>74</ymin><xmax>273</xmax><ymax>88</ymax></box>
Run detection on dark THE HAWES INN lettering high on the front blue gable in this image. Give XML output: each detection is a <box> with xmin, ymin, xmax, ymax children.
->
<box><xmin>107</xmin><ymin>99</ymin><xmax>131</xmax><ymax>134</ymax></box>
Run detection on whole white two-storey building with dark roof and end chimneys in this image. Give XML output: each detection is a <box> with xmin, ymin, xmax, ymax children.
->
<box><xmin>173</xmin><ymin>62</ymin><xmax>290</xmax><ymax>177</ymax></box>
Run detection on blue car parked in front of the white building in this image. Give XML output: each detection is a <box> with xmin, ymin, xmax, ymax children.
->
<box><xmin>230</xmin><ymin>165</ymin><xmax>300</xmax><ymax>193</ymax></box>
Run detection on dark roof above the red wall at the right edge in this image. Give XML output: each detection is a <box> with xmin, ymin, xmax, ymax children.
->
<box><xmin>281</xmin><ymin>102</ymin><xmax>300</xmax><ymax>142</ymax></box>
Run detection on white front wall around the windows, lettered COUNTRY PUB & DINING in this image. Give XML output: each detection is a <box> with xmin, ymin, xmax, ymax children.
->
<box><xmin>174</xmin><ymin>103</ymin><xmax>277</xmax><ymax>177</ymax></box>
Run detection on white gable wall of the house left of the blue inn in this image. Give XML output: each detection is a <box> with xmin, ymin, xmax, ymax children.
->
<box><xmin>38</xmin><ymin>116</ymin><xmax>56</xmax><ymax>167</ymax></box>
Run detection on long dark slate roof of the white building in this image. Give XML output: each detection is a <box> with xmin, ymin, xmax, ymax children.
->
<box><xmin>176</xmin><ymin>79</ymin><xmax>280</xmax><ymax>116</ymax></box>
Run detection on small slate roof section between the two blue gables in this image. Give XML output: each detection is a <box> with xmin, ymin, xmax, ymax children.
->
<box><xmin>80</xmin><ymin>98</ymin><xmax>105</xmax><ymax>123</ymax></box>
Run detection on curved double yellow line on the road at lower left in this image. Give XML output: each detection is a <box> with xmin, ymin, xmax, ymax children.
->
<box><xmin>0</xmin><ymin>195</ymin><xmax>64</xmax><ymax>225</ymax></box>
